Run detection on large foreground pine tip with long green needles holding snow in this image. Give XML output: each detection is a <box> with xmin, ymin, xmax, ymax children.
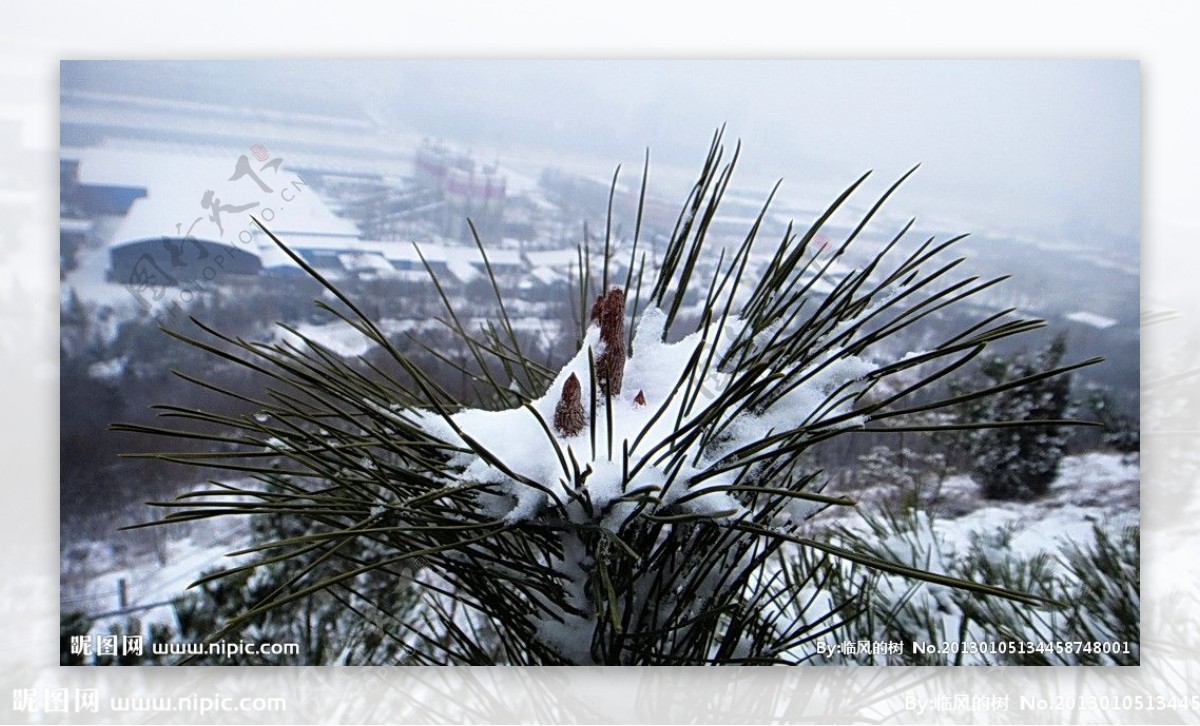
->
<box><xmin>124</xmin><ymin>133</ymin><xmax>1086</xmax><ymax>665</ymax></box>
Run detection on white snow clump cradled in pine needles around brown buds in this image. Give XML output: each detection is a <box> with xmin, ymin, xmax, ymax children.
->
<box><xmin>421</xmin><ymin>300</ymin><xmax>875</xmax><ymax>527</ymax></box>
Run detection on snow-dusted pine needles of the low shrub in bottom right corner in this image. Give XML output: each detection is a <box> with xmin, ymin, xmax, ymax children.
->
<box><xmin>826</xmin><ymin>511</ymin><xmax>1141</xmax><ymax>665</ymax></box>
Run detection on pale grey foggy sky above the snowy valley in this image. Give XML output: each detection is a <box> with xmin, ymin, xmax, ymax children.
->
<box><xmin>62</xmin><ymin>60</ymin><xmax>1140</xmax><ymax>241</ymax></box>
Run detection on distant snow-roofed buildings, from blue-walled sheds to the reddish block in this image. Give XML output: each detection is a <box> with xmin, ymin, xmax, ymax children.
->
<box><xmin>61</xmin><ymin>145</ymin><xmax>577</xmax><ymax>297</ymax></box>
